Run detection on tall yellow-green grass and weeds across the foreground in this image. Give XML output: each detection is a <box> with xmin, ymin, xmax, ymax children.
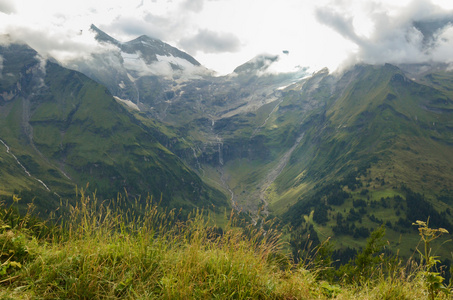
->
<box><xmin>0</xmin><ymin>190</ymin><xmax>450</xmax><ymax>299</ymax></box>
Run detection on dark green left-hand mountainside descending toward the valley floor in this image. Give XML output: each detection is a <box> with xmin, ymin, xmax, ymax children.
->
<box><xmin>0</xmin><ymin>40</ymin><xmax>227</xmax><ymax>213</ymax></box>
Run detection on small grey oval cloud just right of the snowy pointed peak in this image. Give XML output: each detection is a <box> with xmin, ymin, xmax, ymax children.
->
<box><xmin>179</xmin><ymin>29</ymin><xmax>241</xmax><ymax>54</ymax></box>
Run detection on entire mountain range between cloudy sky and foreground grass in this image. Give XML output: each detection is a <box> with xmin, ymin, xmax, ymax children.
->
<box><xmin>0</xmin><ymin>25</ymin><xmax>453</xmax><ymax>254</ymax></box>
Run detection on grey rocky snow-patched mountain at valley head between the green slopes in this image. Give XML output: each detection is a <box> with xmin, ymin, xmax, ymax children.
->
<box><xmin>69</xmin><ymin>26</ymin><xmax>308</xmax><ymax>206</ymax></box>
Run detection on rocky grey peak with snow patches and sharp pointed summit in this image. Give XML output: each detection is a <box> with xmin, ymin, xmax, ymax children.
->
<box><xmin>71</xmin><ymin>25</ymin><xmax>212</xmax><ymax>109</ymax></box>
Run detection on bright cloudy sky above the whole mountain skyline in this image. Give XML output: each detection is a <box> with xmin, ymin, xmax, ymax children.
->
<box><xmin>0</xmin><ymin>0</ymin><xmax>453</xmax><ymax>75</ymax></box>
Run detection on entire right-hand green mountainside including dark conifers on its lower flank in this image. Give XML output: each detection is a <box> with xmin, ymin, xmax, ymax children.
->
<box><xmin>270</xmin><ymin>65</ymin><xmax>453</xmax><ymax>256</ymax></box>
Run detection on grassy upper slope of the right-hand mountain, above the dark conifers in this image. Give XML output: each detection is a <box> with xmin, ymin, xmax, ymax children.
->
<box><xmin>262</xmin><ymin>65</ymin><xmax>453</xmax><ymax>255</ymax></box>
